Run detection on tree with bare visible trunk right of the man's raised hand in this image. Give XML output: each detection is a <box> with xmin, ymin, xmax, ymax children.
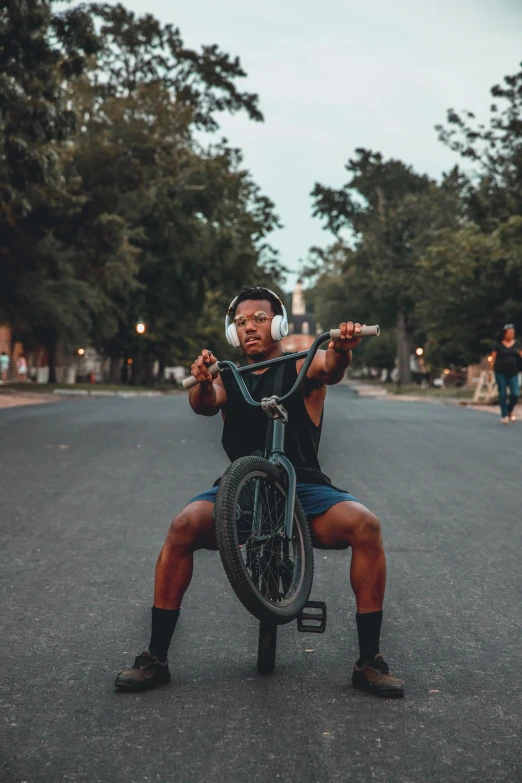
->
<box><xmin>312</xmin><ymin>149</ymin><xmax>462</xmax><ymax>383</ymax></box>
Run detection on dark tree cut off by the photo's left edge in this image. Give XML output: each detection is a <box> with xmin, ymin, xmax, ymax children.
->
<box><xmin>0</xmin><ymin>0</ymin><xmax>101</xmax><ymax>374</ymax></box>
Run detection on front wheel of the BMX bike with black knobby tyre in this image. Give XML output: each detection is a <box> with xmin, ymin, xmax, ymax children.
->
<box><xmin>214</xmin><ymin>457</ymin><xmax>314</xmax><ymax>625</ymax></box>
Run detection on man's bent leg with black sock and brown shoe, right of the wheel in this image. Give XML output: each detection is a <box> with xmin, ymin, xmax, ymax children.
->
<box><xmin>310</xmin><ymin>501</ymin><xmax>404</xmax><ymax>696</ymax></box>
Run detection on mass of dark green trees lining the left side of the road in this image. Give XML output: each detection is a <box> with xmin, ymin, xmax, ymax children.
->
<box><xmin>0</xmin><ymin>0</ymin><xmax>283</xmax><ymax>380</ymax></box>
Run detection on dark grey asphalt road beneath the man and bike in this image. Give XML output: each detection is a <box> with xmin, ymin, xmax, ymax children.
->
<box><xmin>0</xmin><ymin>387</ymin><xmax>522</xmax><ymax>783</ymax></box>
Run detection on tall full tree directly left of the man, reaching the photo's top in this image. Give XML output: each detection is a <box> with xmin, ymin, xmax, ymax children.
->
<box><xmin>71</xmin><ymin>5</ymin><xmax>280</xmax><ymax>374</ymax></box>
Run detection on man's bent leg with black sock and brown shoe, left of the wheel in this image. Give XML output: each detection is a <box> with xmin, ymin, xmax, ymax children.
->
<box><xmin>115</xmin><ymin>501</ymin><xmax>217</xmax><ymax>690</ymax></box>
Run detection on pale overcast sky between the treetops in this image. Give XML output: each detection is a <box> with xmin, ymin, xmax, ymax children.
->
<box><xmin>103</xmin><ymin>0</ymin><xmax>522</xmax><ymax>285</ymax></box>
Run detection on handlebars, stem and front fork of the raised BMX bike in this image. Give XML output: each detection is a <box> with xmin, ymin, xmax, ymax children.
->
<box><xmin>218</xmin><ymin>332</ymin><xmax>332</xmax><ymax>539</ymax></box>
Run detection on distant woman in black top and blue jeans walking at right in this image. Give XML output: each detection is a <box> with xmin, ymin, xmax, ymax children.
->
<box><xmin>491</xmin><ymin>324</ymin><xmax>522</xmax><ymax>424</ymax></box>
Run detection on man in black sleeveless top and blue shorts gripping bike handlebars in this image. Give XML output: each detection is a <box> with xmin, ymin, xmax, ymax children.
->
<box><xmin>115</xmin><ymin>287</ymin><xmax>404</xmax><ymax>696</ymax></box>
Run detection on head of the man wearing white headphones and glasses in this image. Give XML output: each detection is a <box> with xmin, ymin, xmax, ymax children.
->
<box><xmin>228</xmin><ymin>286</ymin><xmax>285</xmax><ymax>359</ymax></box>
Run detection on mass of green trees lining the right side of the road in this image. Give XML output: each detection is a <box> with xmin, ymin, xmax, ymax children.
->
<box><xmin>308</xmin><ymin>63</ymin><xmax>522</xmax><ymax>382</ymax></box>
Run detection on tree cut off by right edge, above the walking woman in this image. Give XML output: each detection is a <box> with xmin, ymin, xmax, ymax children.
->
<box><xmin>421</xmin><ymin>62</ymin><xmax>522</xmax><ymax>364</ymax></box>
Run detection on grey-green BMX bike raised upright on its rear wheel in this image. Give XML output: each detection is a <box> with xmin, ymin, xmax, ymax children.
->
<box><xmin>183</xmin><ymin>325</ymin><xmax>380</xmax><ymax>674</ymax></box>
